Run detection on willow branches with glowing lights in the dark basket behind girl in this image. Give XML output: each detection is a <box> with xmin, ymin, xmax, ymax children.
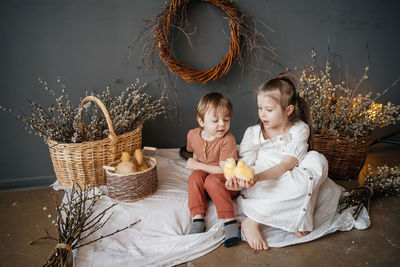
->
<box><xmin>299</xmin><ymin>50</ymin><xmax>400</xmax><ymax>140</ymax></box>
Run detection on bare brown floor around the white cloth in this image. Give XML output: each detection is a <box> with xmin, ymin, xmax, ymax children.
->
<box><xmin>0</xmin><ymin>143</ymin><xmax>400</xmax><ymax>267</ymax></box>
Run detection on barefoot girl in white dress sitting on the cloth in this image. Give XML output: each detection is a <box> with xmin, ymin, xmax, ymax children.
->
<box><xmin>226</xmin><ymin>74</ymin><xmax>340</xmax><ymax>250</ymax></box>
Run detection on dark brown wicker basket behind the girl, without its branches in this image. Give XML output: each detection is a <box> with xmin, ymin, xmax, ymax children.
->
<box><xmin>312</xmin><ymin>133</ymin><xmax>370</xmax><ymax>180</ymax></box>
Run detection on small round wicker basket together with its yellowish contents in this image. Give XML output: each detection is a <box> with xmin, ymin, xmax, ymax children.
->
<box><xmin>103</xmin><ymin>149</ymin><xmax>158</xmax><ymax>202</ymax></box>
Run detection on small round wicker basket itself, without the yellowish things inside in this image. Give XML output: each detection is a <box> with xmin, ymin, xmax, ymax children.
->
<box><xmin>106</xmin><ymin>156</ymin><xmax>157</xmax><ymax>202</ymax></box>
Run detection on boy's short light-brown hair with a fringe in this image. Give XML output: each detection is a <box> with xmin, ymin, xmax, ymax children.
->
<box><xmin>196</xmin><ymin>92</ymin><xmax>233</xmax><ymax>120</ymax></box>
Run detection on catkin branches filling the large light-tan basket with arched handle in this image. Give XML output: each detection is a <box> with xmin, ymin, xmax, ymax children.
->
<box><xmin>0</xmin><ymin>78</ymin><xmax>169</xmax><ymax>143</ymax></box>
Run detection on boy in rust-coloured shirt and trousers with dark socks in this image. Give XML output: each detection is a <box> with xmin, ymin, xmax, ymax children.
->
<box><xmin>186</xmin><ymin>93</ymin><xmax>239</xmax><ymax>247</ymax></box>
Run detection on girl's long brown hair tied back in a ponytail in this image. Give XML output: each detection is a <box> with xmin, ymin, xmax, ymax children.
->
<box><xmin>257</xmin><ymin>73</ymin><xmax>312</xmax><ymax>144</ymax></box>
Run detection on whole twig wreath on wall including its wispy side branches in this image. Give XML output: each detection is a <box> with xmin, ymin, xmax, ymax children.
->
<box><xmin>115</xmin><ymin>0</ymin><xmax>281</xmax><ymax>87</ymax></box>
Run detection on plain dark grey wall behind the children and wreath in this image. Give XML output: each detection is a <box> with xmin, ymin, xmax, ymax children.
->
<box><xmin>0</xmin><ymin>0</ymin><xmax>400</xmax><ymax>189</ymax></box>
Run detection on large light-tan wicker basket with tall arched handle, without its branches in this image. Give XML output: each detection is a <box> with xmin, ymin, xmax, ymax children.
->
<box><xmin>47</xmin><ymin>96</ymin><xmax>142</xmax><ymax>188</ymax></box>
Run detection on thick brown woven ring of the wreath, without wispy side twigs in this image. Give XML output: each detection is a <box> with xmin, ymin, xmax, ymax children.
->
<box><xmin>155</xmin><ymin>0</ymin><xmax>243</xmax><ymax>84</ymax></box>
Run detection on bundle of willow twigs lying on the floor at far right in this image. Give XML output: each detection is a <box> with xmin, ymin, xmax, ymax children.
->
<box><xmin>339</xmin><ymin>164</ymin><xmax>400</xmax><ymax>218</ymax></box>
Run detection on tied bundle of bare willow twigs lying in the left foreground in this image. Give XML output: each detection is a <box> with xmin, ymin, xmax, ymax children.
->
<box><xmin>30</xmin><ymin>184</ymin><xmax>140</xmax><ymax>267</ymax></box>
